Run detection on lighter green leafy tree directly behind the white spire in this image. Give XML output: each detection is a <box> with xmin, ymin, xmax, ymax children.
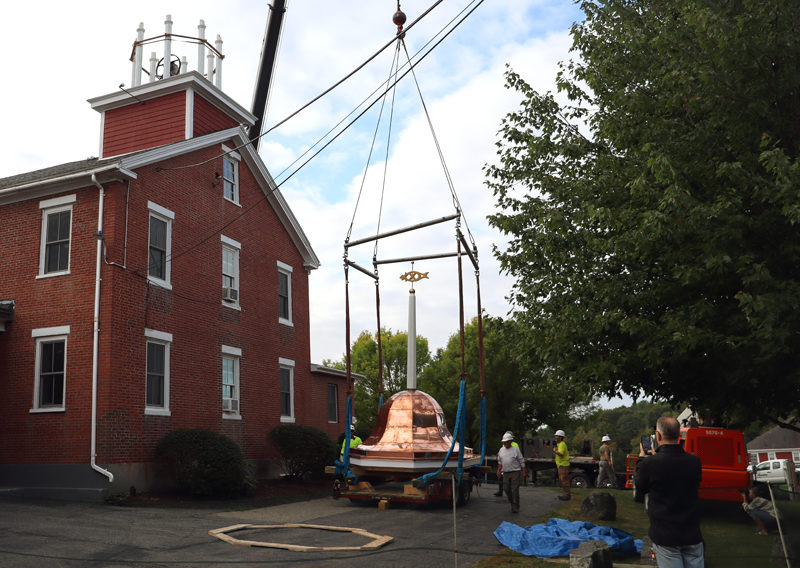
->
<box><xmin>323</xmin><ymin>328</ymin><xmax>431</xmax><ymax>432</ymax></box>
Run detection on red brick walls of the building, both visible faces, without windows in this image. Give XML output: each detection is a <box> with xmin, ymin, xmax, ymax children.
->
<box><xmin>0</xmin><ymin>142</ymin><xmax>326</xmax><ymax>474</ymax></box>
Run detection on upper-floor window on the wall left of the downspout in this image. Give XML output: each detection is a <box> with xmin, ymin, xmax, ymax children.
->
<box><xmin>39</xmin><ymin>194</ymin><xmax>75</xmax><ymax>277</ymax></box>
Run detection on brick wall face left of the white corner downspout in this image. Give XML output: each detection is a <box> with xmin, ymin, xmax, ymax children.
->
<box><xmin>0</xmin><ymin>189</ymin><xmax>98</xmax><ymax>464</ymax></box>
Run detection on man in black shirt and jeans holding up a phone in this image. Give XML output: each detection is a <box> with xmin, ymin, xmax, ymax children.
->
<box><xmin>634</xmin><ymin>416</ymin><xmax>705</xmax><ymax>568</ymax></box>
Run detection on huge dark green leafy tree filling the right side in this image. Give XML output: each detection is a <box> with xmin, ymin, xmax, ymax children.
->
<box><xmin>487</xmin><ymin>0</ymin><xmax>800</xmax><ymax>424</ymax></box>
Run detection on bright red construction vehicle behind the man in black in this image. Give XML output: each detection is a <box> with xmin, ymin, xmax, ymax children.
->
<box><xmin>625</xmin><ymin>426</ymin><xmax>750</xmax><ymax>501</ymax></box>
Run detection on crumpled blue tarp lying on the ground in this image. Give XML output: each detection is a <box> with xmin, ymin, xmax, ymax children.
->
<box><xmin>494</xmin><ymin>519</ymin><xmax>642</xmax><ymax>558</ymax></box>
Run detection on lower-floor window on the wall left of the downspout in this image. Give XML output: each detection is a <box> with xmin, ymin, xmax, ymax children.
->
<box><xmin>31</xmin><ymin>325</ymin><xmax>69</xmax><ymax>412</ymax></box>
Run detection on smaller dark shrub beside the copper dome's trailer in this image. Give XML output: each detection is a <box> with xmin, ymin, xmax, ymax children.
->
<box><xmin>269</xmin><ymin>424</ymin><xmax>339</xmax><ymax>479</ymax></box>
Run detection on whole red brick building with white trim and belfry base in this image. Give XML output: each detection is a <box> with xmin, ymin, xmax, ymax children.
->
<box><xmin>0</xmin><ymin>31</ymin><xmax>345</xmax><ymax>499</ymax></box>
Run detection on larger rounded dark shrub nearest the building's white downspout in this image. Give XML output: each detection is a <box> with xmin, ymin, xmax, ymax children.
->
<box><xmin>156</xmin><ymin>428</ymin><xmax>250</xmax><ymax>497</ymax></box>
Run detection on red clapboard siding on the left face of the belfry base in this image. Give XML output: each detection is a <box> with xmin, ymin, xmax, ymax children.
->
<box><xmin>102</xmin><ymin>91</ymin><xmax>186</xmax><ymax>157</ymax></box>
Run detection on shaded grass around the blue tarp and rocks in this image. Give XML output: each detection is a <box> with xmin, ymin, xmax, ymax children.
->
<box><xmin>476</xmin><ymin>489</ymin><xmax>800</xmax><ymax>568</ymax></box>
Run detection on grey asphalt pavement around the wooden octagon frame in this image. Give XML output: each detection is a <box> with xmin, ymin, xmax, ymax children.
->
<box><xmin>0</xmin><ymin>485</ymin><xmax>560</xmax><ymax>568</ymax></box>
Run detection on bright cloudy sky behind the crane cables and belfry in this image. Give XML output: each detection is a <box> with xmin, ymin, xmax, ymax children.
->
<box><xmin>0</xmin><ymin>0</ymin><xmax>636</xmax><ymax>408</ymax></box>
